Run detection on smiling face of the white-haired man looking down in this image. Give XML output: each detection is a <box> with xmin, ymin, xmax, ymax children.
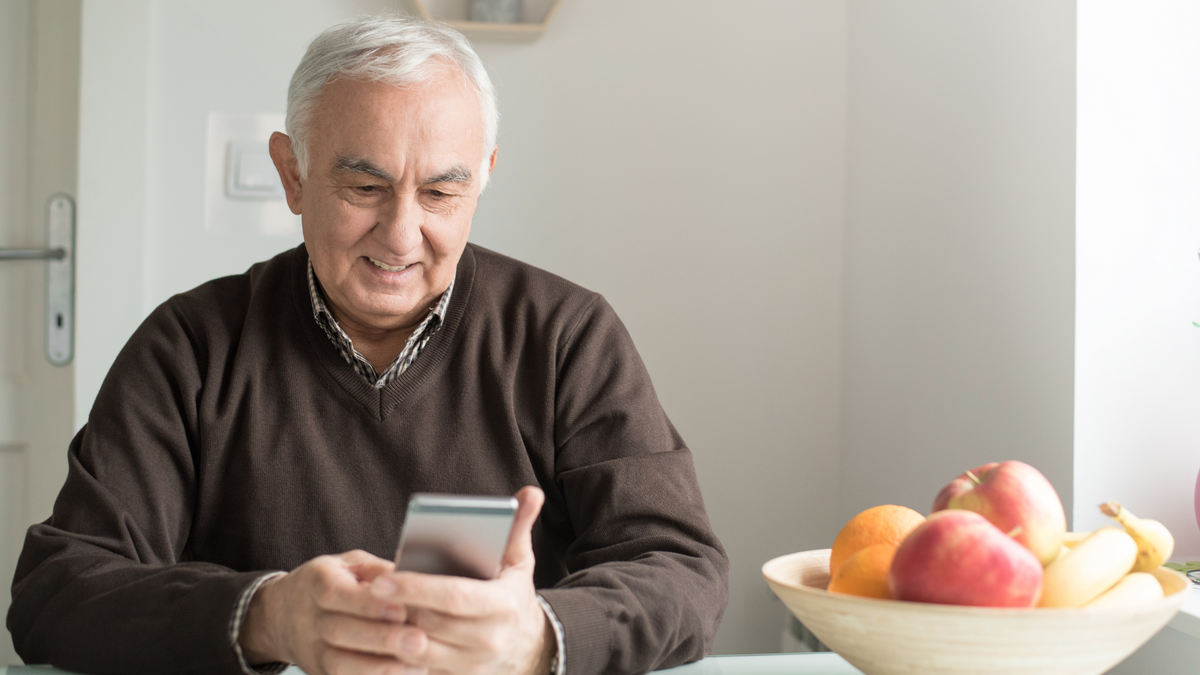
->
<box><xmin>271</xmin><ymin>68</ymin><xmax>496</xmax><ymax>331</ymax></box>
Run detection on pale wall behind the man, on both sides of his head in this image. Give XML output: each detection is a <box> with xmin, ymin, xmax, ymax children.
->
<box><xmin>77</xmin><ymin>0</ymin><xmax>846</xmax><ymax>652</ymax></box>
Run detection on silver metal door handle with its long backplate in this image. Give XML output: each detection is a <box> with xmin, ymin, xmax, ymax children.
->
<box><xmin>0</xmin><ymin>193</ymin><xmax>74</xmax><ymax>365</ymax></box>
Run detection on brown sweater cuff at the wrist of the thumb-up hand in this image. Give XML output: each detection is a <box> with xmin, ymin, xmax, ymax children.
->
<box><xmin>538</xmin><ymin>589</ymin><xmax>613</xmax><ymax>675</ymax></box>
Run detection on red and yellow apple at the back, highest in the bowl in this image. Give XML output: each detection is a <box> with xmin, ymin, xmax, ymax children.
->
<box><xmin>932</xmin><ymin>461</ymin><xmax>1067</xmax><ymax>566</ymax></box>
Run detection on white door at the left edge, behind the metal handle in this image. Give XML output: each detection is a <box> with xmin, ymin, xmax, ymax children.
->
<box><xmin>0</xmin><ymin>0</ymin><xmax>80</xmax><ymax>665</ymax></box>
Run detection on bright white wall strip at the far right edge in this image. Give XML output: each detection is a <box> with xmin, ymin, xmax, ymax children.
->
<box><xmin>1074</xmin><ymin>0</ymin><xmax>1200</xmax><ymax>560</ymax></box>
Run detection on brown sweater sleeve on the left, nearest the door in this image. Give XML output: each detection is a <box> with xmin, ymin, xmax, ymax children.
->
<box><xmin>7</xmin><ymin>301</ymin><xmax>267</xmax><ymax>674</ymax></box>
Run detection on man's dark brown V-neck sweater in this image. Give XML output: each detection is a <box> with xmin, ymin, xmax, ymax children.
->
<box><xmin>7</xmin><ymin>246</ymin><xmax>728</xmax><ymax>675</ymax></box>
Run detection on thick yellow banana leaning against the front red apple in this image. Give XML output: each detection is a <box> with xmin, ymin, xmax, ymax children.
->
<box><xmin>1038</xmin><ymin>527</ymin><xmax>1138</xmax><ymax>607</ymax></box>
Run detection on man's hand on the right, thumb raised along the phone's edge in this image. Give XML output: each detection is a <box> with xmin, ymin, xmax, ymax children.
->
<box><xmin>371</xmin><ymin>486</ymin><xmax>554</xmax><ymax>675</ymax></box>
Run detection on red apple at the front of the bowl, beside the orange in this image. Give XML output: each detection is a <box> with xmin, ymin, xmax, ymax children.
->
<box><xmin>888</xmin><ymin>509</ymin><xmax>1042</xmax><ymax>608</ymax></box>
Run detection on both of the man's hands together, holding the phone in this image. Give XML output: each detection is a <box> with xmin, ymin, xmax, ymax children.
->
<box><xmin>238</xmin><ymin>486</ymin><xmax>554</xmax><ymax>675</ymax></box>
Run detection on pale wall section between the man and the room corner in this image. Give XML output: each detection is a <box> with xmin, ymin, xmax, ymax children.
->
<box><xmin>463</xmin><ymin>0</ymin><xmax>845</xmax><ymax>652</ymax></box>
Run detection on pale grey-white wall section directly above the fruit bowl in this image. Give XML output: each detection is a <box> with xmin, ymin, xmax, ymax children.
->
<box><xmin>839</xmin><ymin>0</ymin><xmax>1075</xmax><ymax>522</ymax></box>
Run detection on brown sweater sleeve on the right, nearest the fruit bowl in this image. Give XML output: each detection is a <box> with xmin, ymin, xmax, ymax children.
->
<box><xmin>541</xmin><ymin>298</ymin><xmax>728</xmax><ymax>675</ymax></box>
